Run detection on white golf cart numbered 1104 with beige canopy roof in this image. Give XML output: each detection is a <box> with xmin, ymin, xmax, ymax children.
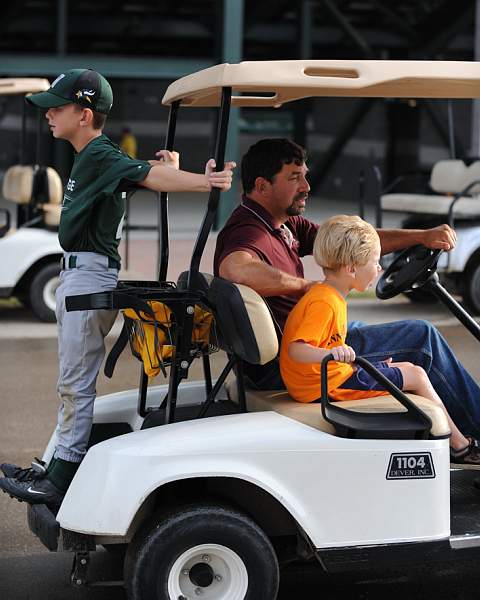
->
<box><xmin>23</xmin><ymin>61</ymin><xmax>480</xmax><ymax>600</ymax></box>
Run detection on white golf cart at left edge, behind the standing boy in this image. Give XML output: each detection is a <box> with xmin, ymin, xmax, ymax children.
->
<box><xmin>0</xmin><ymin>77</ymin><xmax>63</xmax><ymax>321</ymax></box>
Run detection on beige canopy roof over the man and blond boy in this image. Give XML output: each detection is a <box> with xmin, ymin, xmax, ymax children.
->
<box><xmin>163</xmin><ymin>60</ymin><xmax>480</xmax><ymax>107</ymax></box>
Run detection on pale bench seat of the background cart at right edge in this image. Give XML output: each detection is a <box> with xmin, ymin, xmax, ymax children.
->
<box><xmin>380</xmin><ymin>159</ymin><xmax>480</xmax><ymax>222</ymax></box>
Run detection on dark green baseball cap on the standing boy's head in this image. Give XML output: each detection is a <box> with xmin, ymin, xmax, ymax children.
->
<box><xmin>26</xmin><ymin>69</ymin><xmax>113</xmax><ymax>115</ymax></box>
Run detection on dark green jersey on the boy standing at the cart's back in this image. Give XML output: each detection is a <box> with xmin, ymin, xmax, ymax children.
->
<box><xmin>58</xmin><ymin>134</ymin><xmax>151</xmax><ymax>263</ymax></box>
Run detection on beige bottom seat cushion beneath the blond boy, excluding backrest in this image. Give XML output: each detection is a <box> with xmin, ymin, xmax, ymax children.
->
<box><xmin>226</xmin><ymin>381</ymin><xmax>450</xmax><ymax>438</ymax></box>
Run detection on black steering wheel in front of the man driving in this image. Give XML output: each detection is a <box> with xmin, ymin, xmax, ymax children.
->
<box><xmin>376</xmin><ymin>245</ymin><xmax>443</xmax><ymax>300</ymax></box>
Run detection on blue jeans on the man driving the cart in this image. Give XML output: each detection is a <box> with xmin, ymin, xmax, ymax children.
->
<box><xmin>346</xmin><ymin>320</ymin><xmax>480</xmax><ymax>439</ymax></box>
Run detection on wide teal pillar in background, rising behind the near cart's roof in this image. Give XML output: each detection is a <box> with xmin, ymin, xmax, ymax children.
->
<box><xmin>214</xmin><ymin>0</ymin><xmax>245</xmax><ymax>229</ymax></box>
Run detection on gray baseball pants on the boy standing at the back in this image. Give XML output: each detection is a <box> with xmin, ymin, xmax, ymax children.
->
<box><xmin>55</xmin><ymin>252</ymin><xmax>118</xmax><ymax>462</ymax></box>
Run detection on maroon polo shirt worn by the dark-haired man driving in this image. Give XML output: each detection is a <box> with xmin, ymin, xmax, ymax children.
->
<box><xmin>213</xmin><ymin>197</ymin><xmax>318</xmax><ymax>331</ymax></box>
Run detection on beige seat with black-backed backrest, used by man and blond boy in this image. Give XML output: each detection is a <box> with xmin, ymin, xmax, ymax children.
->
<box><xmin>203</xmin><ymin>275</ymin><xmax>450</xmax><ymax>438</ymax></box>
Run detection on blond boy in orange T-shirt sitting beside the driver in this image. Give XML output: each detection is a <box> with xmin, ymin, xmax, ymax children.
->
<box><xmin>280</xmin><ymin>215</ymin><xmax>480</xmax><ymax>467</ymax></box>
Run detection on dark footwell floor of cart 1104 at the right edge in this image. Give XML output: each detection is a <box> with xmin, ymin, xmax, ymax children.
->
<box><xmin>450</xmin><ymin>469</ymin><xmax>480</xmax><ymax>535</ymax></box>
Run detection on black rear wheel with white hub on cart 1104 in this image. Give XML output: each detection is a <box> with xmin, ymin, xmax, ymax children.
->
<box><xmin>125</xmin><ymin>503</ymin><xmax>279</xmax><ymax>600</ymax></box>
